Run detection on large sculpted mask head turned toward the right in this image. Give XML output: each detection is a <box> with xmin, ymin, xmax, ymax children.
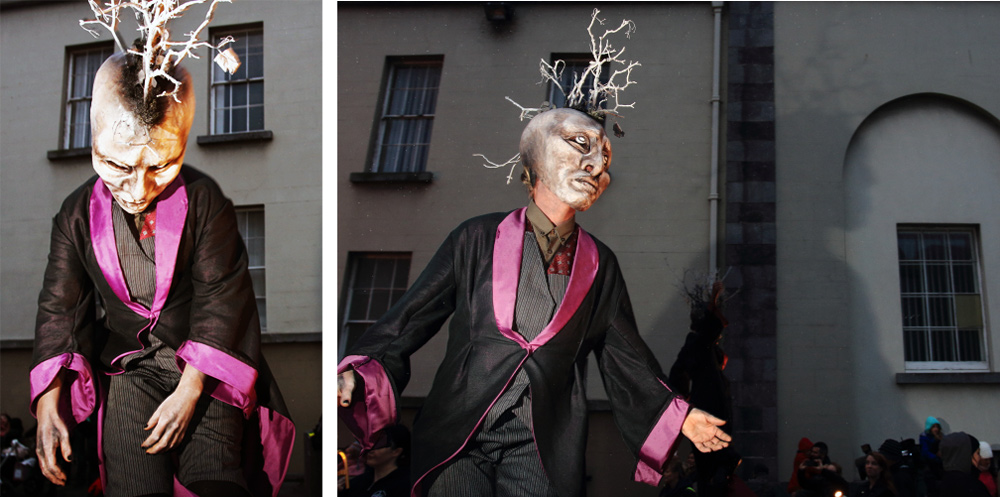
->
<box><xmin>521</xmin><ymin>109</ymin><xmax>611</xmax><ymax>211</ymax></box>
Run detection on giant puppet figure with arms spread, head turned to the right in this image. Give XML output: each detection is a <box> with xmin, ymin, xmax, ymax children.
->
<box><xmin>338</xmin><ymin>8</ymin><xmax>730</xmax><ymax>497</ymax></box>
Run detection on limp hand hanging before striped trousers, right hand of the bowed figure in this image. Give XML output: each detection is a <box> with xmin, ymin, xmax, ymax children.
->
<box><xmin>142</xmin><ymin>364</ymin><xmax>205</xmax><ymax>454</ymax></box>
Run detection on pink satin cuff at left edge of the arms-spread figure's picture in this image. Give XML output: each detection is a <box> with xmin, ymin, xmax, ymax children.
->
<box><xmin>337</xmin><ymin>355</ymin><xmax>396</xmax><ymax>450</ymax></box>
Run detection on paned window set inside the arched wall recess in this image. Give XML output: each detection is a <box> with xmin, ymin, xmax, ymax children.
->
<box><xmin>897</xmin><ymin>225</ymin><xmax>988</xmax><ymax>371</ymax></box>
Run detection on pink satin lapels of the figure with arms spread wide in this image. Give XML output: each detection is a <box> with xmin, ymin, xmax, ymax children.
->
<box><xmin>493</xmin><ymin>207</ymin><xmax>600</xmax><ymax>352</ymax></box>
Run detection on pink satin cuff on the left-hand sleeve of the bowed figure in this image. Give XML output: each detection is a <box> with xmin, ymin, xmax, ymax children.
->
<box><xmin>29</xmin><ymin>352</ymin><xmax>97</xmax><ymax>423</ymax></box>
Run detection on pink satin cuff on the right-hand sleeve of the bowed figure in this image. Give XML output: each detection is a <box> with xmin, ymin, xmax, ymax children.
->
<box><xmin>176</xmin><ymin>340</ymin><xmax>257</xmax><ymax>417</ymax></box>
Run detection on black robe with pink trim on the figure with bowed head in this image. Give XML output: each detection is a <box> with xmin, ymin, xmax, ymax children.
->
<box><xmin>31</xmin><ymin>166</ymin><xmax>294</xmax><ymax>494</ymax></box>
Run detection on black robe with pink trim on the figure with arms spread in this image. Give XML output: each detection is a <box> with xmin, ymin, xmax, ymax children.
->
<box><xmin>340</xmin><ymin>209</ymin><xmax>688</xmax><ymax>496</ymax></box>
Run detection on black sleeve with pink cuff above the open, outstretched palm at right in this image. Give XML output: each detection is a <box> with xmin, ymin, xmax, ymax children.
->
<box><xmin>595</xmin><ymin>265</ymin><xmax>690</xmax><ymax>485</ymax></box>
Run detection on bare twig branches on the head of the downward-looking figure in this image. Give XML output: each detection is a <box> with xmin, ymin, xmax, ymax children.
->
<box><xmin>80</xmin><ymin>0</ymin><xmax>238</xmax><ymax>101</ymax></box>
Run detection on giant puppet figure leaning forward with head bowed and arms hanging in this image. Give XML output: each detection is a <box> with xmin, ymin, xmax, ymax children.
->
<box><xmin>31</xmin><ymin>3</ymin><xmax>294</xmax><ymax>497</ymax></box>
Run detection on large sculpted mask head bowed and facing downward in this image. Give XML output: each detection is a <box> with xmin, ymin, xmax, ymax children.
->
<box><xmin>90</xmin><ymin>53</ymin><xmax>195</xmax><ymax>214</ymax></box>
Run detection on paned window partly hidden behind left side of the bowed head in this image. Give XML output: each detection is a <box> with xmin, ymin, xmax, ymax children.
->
<box><xmin>62</xmin><ymin>44</ymin><xmax>113</xmax><ymax>149</ymax></box>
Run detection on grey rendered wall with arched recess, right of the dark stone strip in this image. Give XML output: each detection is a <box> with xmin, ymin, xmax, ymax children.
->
<box><xmin>774</xmin><ymin>2</ymin><xmax>1000</xmax><ymax>472</ymax></box>
